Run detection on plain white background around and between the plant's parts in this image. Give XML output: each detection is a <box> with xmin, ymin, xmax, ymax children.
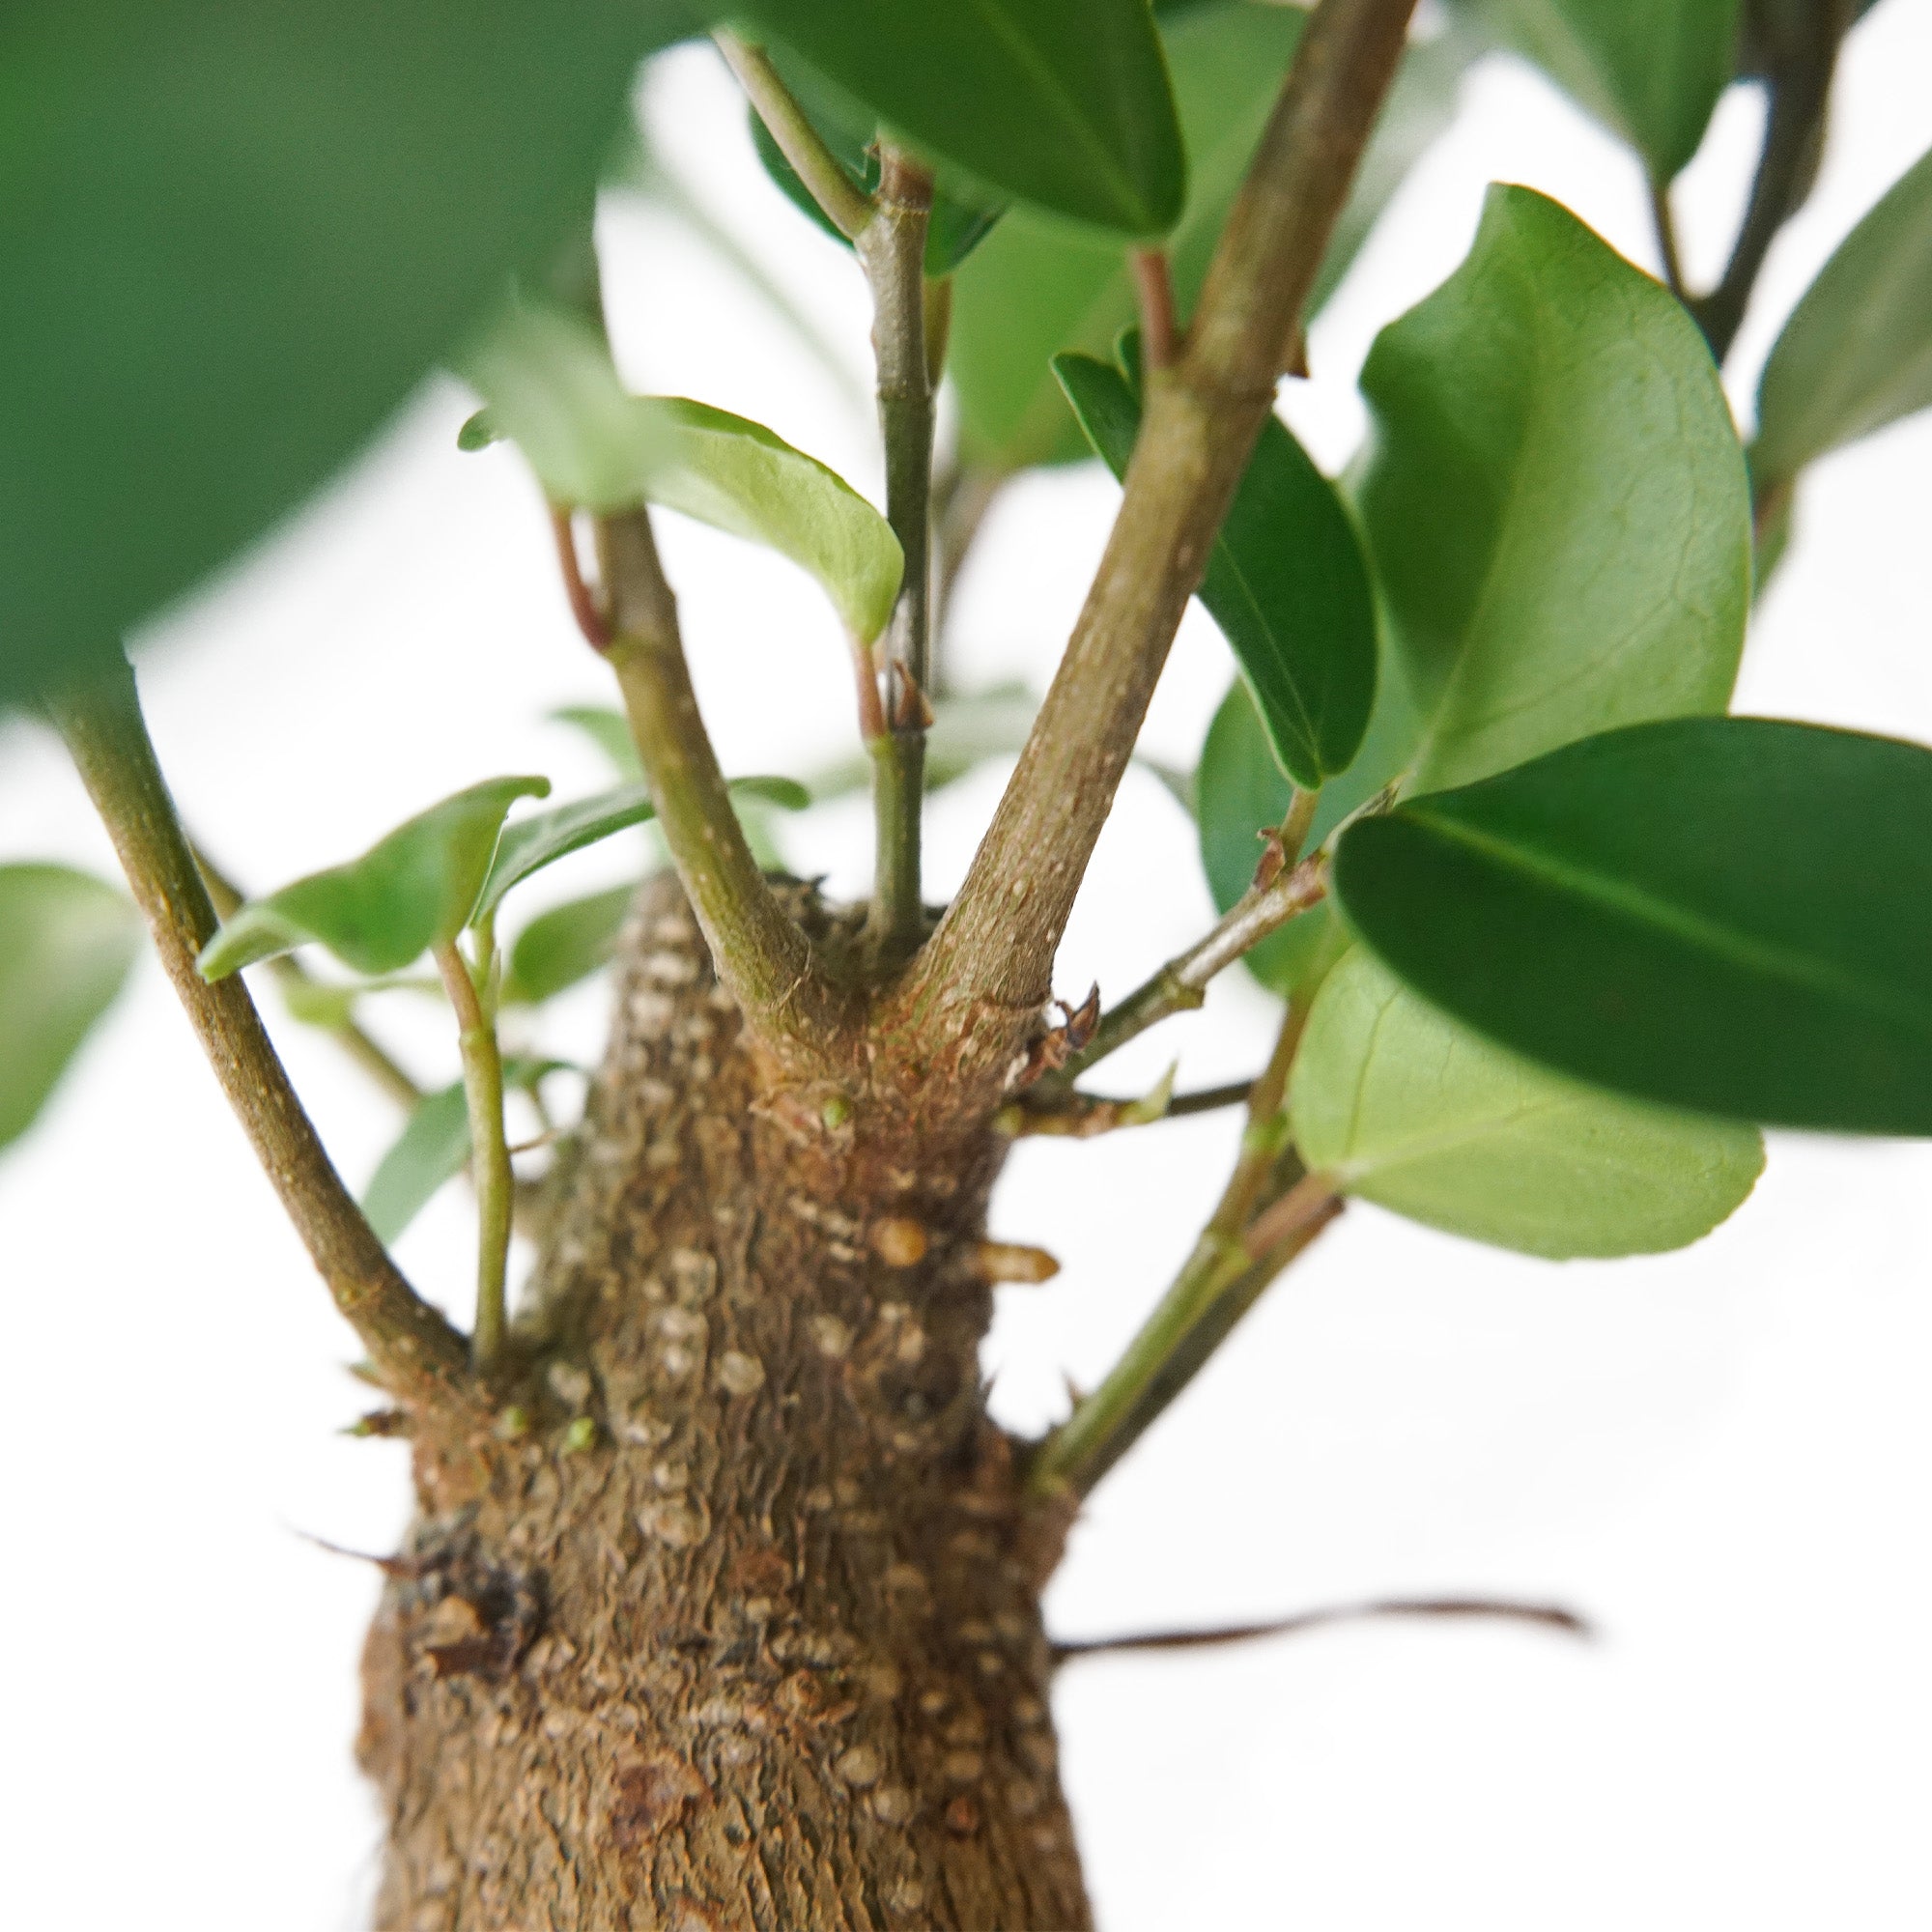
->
<box><xmin>0</xmin><ymin>0</ymin><xmax>1932</xmax><ymax>1932</ymax></box>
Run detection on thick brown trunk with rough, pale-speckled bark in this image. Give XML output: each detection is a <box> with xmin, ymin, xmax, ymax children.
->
<box><xmin>361</xmin><ymin>885</ymin><xmax>1090</xmax><ymax>1932</ymax></box>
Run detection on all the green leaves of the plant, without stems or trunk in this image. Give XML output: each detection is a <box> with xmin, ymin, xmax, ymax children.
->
<box><xmin>0</xmin><ymin>0</ymin><xmax>1932</xmax><ymax>1314</ymax></box>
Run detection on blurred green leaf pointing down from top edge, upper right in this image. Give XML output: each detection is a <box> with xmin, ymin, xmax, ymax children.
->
<box><xmin>1468</xmin><ymin>0</ymin><xmax>1741</xmax><ymax>182</ymax></box>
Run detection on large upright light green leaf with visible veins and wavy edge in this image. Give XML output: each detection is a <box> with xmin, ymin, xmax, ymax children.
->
<box><xmin>1358</xmin><ymin>187</ymin><xmax>1750</xmax><ymax>790</ymax></box>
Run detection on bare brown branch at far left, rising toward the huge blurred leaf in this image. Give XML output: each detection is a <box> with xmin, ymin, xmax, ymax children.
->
<box><xmin>48</xmin><ymin>663</ymin><xmax>473</xmax><ymax>1408</ymax></box>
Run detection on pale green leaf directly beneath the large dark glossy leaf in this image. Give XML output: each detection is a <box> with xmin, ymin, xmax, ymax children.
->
<box><xmin>1289</xmin><ymin>947</ymin><xmax>1764</xmax><ymax>1262</ymax></box>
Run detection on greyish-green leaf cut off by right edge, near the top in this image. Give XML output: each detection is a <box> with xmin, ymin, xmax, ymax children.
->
<box><xmin>1750</xmin><ymin>153</ymin><xmax>1932</xmax><ymax>487</ymax></box>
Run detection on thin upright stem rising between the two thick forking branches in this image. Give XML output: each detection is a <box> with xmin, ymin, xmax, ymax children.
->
<box><xmin>858</xmin><ymin>143</ymin><xmax>933</xmax><ymax>960</ymax></box>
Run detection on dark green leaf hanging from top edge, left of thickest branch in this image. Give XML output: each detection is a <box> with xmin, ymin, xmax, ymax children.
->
<box><xmin>744</xmin><ymin>0</ymin><xmax>1186</xmax><ymax>236</ymax></box>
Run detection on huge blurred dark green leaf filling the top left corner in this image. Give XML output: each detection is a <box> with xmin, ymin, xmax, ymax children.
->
<box><xmin>0</xmin><ymin>0</ymin><xmax>692</xmax><ymax>703</ymax></box>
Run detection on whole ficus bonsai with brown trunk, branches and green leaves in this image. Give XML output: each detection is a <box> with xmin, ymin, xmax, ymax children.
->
<box><xmin>0</xmin><ymin>0</ymin><xmax>1932</xmax><ymax>1932</ymax></box>
